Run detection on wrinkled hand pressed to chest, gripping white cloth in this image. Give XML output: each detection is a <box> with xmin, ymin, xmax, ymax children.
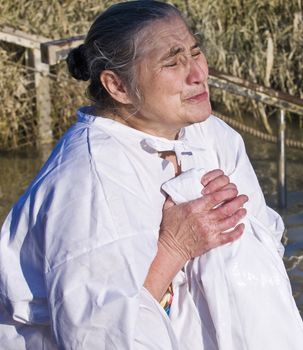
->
<box><xmin>159</xmin><ymin>170</ymin><xmax>248</xmax><ymax>261</ymax></box>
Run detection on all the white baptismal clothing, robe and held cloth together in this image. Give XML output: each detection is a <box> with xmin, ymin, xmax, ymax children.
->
<box><xmin>0</xmin><ymin>108</ymin><xmax>303</xmax><ymax>350</ymax></box>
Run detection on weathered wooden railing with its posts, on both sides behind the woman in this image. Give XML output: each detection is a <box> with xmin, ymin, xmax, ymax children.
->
<box><xmin>0</xmin><ymin>27</ymin><xmax>303</xmax><ymax>208</ymax></box>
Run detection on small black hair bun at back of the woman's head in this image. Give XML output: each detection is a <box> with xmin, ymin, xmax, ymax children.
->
<box><xmin>66</xmin><ymin>44</ymin><xmax>90</xmax><ymax>81</ymax></box>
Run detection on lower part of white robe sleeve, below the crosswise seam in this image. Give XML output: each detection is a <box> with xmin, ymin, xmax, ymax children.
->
<box><xmin>46</xmin><ymin>237</ymin><xmax>176</xmax><ymax>350</ymax></box>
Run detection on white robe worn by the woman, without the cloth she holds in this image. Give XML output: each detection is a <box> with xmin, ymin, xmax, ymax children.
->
<box><xmin>0</xmin><ymin>109</ymin><xmax>301</xmax><ymax>350</ymax></box>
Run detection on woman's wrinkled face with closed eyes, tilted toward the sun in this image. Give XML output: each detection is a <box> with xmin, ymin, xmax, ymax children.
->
<box><xmin>128</xmin><ymin>17</ymin><xmax>211</xmax><ymax>138</ymax></box>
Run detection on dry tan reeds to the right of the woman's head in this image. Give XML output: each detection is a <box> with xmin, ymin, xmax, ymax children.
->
<box><xmin>178</xmin><ymin>0</ymin><xmax>303</xmax><ymax>132</ymax></box>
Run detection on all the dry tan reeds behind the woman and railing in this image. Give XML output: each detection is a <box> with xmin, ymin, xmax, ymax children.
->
<box><xmin>0</xmin><ymin>0</ymin><xmax>303</xmax><ymax>149</ymax></box>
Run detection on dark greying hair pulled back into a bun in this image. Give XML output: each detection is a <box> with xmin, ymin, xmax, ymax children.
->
<box><xmin>67</xmin><ymin>0</ymin><xmax>182</xmax><ymax>109</ymax></box>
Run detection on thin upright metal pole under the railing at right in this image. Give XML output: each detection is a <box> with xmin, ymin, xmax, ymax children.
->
<box><xmin>278</xmin><ymin>109</ymin><xmax>287</xmax><ymax>209</ymax></box>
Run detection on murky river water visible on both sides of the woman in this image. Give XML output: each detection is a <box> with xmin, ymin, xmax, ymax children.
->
<box><xmin>0</xmin><ymin>130</ymin><xmax>303</xmax><ymax>316</ymax></box>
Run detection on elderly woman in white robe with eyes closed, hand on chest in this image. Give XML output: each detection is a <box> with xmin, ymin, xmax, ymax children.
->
<box><xmin>0</xmin><ymin>1</ymin><xmax>303</xmax><ymax>350</ymax></box>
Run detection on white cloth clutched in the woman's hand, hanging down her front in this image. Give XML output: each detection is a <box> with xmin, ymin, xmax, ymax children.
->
<box><xmin>162</xmin><ymin>169</ymin><xmax>303</xmax><ymax>350</ymax></box>
